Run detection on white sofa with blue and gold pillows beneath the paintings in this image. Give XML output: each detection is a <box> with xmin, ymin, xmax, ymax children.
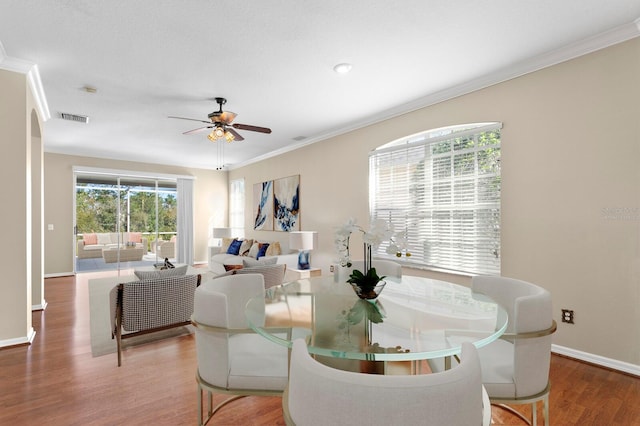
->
<box><xmin>208</xmin><ymin>238</ymin><xmax>298</xmax><ymax>274</ymax></box>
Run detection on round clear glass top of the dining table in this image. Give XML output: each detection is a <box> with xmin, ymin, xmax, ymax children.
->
<box><xmin>245</xmin><ymin>276</ymin><xmax>507</xmax><ymax>361</ymax></box>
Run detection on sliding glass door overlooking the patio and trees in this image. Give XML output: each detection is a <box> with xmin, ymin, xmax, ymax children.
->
<box><xmin>75</xmin><ymin>172</ymin><xmax>178</xmax><ymax>272</ymax></box>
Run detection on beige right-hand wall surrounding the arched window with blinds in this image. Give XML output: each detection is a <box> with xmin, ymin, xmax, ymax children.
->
<box><xmin>230</xmin><ymin>39</ymin><xmax>640</xmax><ymax>367</ymax></box>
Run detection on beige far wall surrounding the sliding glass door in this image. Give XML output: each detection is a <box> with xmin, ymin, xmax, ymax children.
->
<box><xmin>44</xmin><ymin>152</ymin><xmax>228</xmax><ymax>276</ymax></box>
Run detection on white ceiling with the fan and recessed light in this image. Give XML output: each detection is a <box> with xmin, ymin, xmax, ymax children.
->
<box><xmin>0</xmin><ymin>0</ymin><xmax>640</xmax><ymax>169</ymax></box>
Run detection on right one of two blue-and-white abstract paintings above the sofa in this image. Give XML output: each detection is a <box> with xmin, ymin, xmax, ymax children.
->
<box><xmin>273</xmin><ymin>175</ymin><xmax>300</xmax><ymax>232</ymax></box>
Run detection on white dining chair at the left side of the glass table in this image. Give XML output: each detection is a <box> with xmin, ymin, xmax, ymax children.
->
<box><xmin>191</xmin><ymin>273</ymin><xmax>291</xmax><ymax>425</ymax></box>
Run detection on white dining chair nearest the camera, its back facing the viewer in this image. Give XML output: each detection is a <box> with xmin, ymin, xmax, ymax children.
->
<box><xmin>282</xmin><ymin>339</ymin><xmax>491</xmax><ymax>426</ymax></box>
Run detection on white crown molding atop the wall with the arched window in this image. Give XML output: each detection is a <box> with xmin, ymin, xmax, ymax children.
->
<box><xmin>228</xmin><ymin>18</ymin><xmax>640</xmax><ymax>170</ymax></box>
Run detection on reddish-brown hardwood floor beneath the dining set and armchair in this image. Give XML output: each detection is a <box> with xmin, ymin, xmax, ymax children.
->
<box><xmin>0</xmin><ymin>274</ymin><xmax>640</xmax><ymax>426</ymax></box>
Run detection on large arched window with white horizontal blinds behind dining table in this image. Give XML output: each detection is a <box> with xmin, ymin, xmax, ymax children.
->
<box><xmin>369</xmin><ymin>123</ymin><xmax>502</xmax><ymax>274</ymax></box>
